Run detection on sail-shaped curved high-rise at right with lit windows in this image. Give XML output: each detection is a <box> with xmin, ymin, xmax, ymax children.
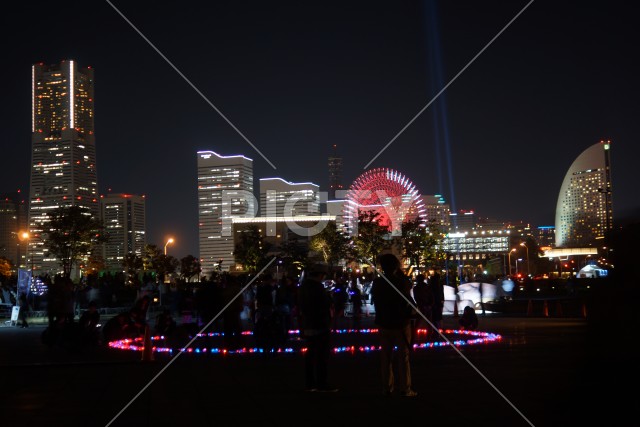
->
<box><xmin>555</xmin><ymin>141</ymin><xmax>613</xmax><ymax>248</ymax></box>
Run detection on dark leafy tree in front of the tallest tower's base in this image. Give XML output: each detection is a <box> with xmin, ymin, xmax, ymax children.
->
<box><xmin>43</xmin><ymin>206</ymin><xmax>108</xmax><ymax>279</ymax></box>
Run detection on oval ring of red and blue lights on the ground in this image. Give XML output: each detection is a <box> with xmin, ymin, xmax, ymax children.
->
<box><xmin>109</xmin><ymin>329</ymin><xmax>502</xmax><ymax>355</ymax></box>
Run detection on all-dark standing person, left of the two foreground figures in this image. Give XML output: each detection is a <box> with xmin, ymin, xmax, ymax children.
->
<box><xmin>298</xmin><ymin>265</ymin><xmax>338</xmax><ymax>392</ymax></box>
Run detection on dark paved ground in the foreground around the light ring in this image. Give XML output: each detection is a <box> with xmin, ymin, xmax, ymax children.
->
<box><xmin>0</xmin><ymin>315</ymin><xmax>629</xmax><ymax>427</ymax></box>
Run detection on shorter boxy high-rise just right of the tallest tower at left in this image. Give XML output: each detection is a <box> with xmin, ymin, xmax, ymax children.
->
<box><xmin>100</xmin><ymin>194</ymin><xmax>147</xmax><ymax>271</ymax></box>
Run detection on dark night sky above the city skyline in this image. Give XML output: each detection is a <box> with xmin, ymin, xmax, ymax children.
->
<box><xmin>0</xmin><ymin>0</ymin><xmax>640</xmax><ymax>257</ymax></box>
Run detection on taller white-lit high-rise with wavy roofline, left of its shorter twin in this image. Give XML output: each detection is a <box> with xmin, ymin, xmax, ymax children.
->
<box><xmin>198</xmin><ymin>151</ymin><xmax>256</xmax><ymax>275</ymax></box>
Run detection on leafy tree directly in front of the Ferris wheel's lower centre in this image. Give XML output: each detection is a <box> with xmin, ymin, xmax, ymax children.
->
<box><xmin>352</xmin><ymin>210</ymin><xmax>390</xmax><ymax>264</ymax></box>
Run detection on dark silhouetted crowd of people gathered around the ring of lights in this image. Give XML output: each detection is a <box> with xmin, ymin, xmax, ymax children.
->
<box><xmin>2</xmin><ymin>253</ymin><xmax>478</xmax><ymax>406</ymax></box>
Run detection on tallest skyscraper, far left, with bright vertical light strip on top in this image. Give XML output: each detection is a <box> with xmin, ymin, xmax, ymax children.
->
<box><xmin>29</xmin><ymin>60</ymin><xmax>99</xmax><ymax>273</ymax></box>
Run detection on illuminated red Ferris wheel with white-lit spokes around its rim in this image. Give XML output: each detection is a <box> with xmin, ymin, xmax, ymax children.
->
<box><xmin>343</xmin><ymin>168</ymin><xmax>426</xmax><ymax>235</ymax></box>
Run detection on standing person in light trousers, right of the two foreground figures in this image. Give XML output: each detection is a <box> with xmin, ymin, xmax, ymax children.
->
<box><xmin>371</xmin><ymin>254</ymin><xmax>418</xmax><ymax>397</ymax></box>
